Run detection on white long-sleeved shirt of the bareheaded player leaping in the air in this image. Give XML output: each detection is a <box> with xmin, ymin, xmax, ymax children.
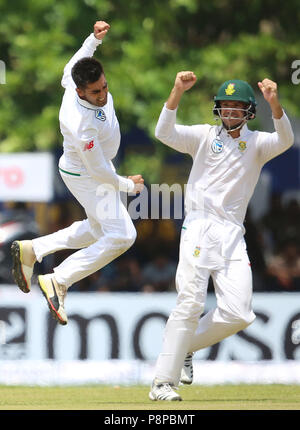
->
<box><xmin>59</xmin><ymin>33</ymin><xmax>134</xmax><ymax>192</ymax></box>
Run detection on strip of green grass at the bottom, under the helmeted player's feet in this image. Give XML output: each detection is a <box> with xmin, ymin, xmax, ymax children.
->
<box><xmin>0</xmin><ymin>385</ymin><xmax>300</xmax><ymax>411</ymax></box>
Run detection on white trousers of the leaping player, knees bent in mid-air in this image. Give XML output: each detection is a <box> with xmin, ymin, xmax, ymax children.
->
<box><xmin>33</xmin><ymin>173</ymin><xmax>136</xmax><ymax>288</ymax></box>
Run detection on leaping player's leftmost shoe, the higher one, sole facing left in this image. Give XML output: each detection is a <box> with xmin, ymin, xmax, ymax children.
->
<box><xmin>11</xmin><ymin>240</ymin><xmax>36</xmax><ymax>293</ymax></box>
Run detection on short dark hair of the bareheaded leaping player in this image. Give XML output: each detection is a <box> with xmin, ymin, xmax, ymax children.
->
<box><xmin>71</xmin><ymin>57</ymin><xmax>104</xmax><ymax>89</ymax></box>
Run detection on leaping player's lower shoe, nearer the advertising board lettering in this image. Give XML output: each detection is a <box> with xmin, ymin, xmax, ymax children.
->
<box><xmin>38</xmin><ymin>274</ymin><xmax>68</xmax><ymax>325</ymax></box>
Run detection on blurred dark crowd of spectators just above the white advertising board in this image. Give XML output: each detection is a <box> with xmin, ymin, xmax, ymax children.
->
<box><xmin>0</xmin><ymin>194</ymin><xmax>300</xmax><ymax>293</ymax></box>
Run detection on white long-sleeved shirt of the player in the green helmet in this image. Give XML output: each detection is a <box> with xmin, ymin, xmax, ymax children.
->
<box><xmin>155</xmin><ymin>105</ymin><xmax>294</xmax><ymax>259</ymax></box>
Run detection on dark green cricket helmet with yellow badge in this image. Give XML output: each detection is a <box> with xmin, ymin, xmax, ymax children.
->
<box><xmin>213</xmin><ymin>79</ymin><xmax>256</xmax><ymax>119</ymax></box>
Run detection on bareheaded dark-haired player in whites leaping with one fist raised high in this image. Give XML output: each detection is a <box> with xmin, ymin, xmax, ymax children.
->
<box><xmin>12</xmin><ymin>21</ymin><xmax>144</xmax><ymax>325</ymax></box>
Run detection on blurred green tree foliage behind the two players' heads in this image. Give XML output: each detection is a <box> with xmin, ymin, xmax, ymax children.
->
<box><xmin>0</xmin><ymin>0</ymin><xmax>300</xmax><ymax>180</ymax></box>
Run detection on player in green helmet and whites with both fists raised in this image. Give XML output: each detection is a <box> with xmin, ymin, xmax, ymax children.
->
<box><xmin>149</xmin><ymin>71</ymin><xmax>294</xmax><ymax>400</ymax></box>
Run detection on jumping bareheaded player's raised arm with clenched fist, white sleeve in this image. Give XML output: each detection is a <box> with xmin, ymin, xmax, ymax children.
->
<box><xmin>61</xmin><ymin>21</ymin><xmax>110</xmax><ymax>88</ymax></box>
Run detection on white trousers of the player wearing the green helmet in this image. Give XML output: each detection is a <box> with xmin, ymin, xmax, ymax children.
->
<box><xmin>155</xmin><ymin>215</ymin><xmax>255</xmax><ymax>386</ymax></box>
